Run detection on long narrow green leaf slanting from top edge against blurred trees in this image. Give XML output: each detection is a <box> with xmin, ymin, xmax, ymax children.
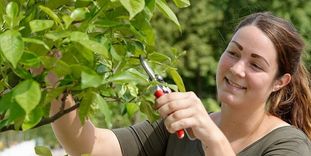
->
<box><xmin>156</xmin><ymin>0</ymin><xmax>180</xmax><ymax>29</ymax></box>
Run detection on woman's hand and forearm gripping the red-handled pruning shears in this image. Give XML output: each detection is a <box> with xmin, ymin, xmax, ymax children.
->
<box><xmin>156</xmin><ymin>92</ymin><xmax>235</xmax><ymax>156</ymax></box>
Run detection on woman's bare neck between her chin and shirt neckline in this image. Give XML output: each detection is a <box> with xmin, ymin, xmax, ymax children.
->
<box><xmin>219</xmin><ymin>104</ymin><xmax>267</xmax><ymax>142</ymax></box>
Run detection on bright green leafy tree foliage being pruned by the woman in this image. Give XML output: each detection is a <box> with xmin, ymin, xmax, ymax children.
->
<box><xmin>0</xmin><ymin>0</ymin><xmax>190</xmax><ymax>131</ymax></box>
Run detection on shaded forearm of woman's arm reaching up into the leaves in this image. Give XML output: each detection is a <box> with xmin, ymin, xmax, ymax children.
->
<box><xmin>50</xmin><ymin>95</ymin><xmax>95</xmax><ymax>155</ymax></box>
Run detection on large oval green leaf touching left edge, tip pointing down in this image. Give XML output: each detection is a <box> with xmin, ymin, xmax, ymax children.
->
<box><xmin>0</xmin><ymin>30</ymin><xmax>24</xmax><ymax>68</ymax></box>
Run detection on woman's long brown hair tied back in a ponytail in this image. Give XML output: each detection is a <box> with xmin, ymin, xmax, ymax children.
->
<box><xmin>236</xmin><ymin>12</ymin><xmax>311</xmax><ymax>139</ymax></box>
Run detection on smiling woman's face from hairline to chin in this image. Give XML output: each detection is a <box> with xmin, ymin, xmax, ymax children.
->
<box><xmin>216</xmin><ymin>25</ymin><xmax>278</xmax><ymax>108</ymax></box>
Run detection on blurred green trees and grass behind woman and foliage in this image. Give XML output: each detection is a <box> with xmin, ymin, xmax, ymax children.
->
<box><xmin>0</xmin><ymin>0</ymin><xmax>311</xmax><ymax>150</ymax></box>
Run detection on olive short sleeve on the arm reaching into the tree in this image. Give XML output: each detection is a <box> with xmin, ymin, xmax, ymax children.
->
<box><xmin>112</xmin><ymin>120</ymin><xmax>169</xmax><ymax>156</ymax></box>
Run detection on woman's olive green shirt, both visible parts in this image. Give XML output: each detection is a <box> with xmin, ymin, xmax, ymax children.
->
<box><xmin>113</xmin><ymin>121</ymin><xmax>311</xmax><ymax>156</ymax></box>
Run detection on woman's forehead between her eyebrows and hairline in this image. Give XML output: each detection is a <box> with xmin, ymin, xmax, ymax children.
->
<box><xmin>230</xmin><ymin>25</ymin><xmax>277</xmax><ymax>64</ymax></box>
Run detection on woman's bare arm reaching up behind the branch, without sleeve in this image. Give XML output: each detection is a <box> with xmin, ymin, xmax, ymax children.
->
<box><xmin>50</xmin><ymin>95</ymin><xmax>122</xmax><ymax>156</ymax></box>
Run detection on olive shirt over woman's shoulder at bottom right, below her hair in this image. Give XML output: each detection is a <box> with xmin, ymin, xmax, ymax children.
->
<box><xmin>238</xmin><ymin>126</ymin><xmax>311</xmax><ymax>156</ymax></box>
